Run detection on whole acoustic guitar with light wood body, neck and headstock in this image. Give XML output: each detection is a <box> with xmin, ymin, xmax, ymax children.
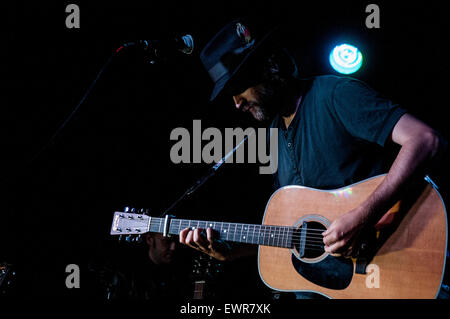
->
<box><xmin>111</xmin><ymin>175</ymin><xmax>447</xmax><ymax>299</ymax></box>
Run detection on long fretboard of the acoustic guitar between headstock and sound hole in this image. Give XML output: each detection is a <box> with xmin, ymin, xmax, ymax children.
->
<box><xmin>149</xmin><ymin>217</ymin><xmax>295</xmax><ymax>248</ymax></box>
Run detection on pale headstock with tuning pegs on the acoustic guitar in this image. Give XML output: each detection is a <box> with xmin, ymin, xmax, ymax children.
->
<box><xmin>110</xmin><ymin>209</ymin><xmax>151</xmax><ymax>241</ymax></box>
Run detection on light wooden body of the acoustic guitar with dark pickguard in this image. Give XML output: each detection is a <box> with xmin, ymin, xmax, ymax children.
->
<box><xmin>258</xmin><ymin>175</ymin><xmax>447</xmax><ymax>299</ymax></box>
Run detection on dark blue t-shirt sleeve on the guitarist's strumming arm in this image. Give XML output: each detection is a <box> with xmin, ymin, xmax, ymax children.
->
<box><xmin>331</xmin><ymin>78</ymin><xmax>406</xmax><ymax>146</ymax></box>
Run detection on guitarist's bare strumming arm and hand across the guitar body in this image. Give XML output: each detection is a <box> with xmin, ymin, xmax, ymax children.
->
<box><xmin>323</xmin><ymin>114</ymin><xmax>447</xmax><ymax>255</ymax></box>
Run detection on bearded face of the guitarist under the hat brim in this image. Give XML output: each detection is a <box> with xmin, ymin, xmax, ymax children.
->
<box><xmin>233</xmin><ymin>84</ymin><xmax>280</xmax><ymax>121</ymax></box>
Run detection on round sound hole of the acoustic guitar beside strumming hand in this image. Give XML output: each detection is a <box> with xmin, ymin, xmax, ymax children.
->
<box><xmin>293</xmin><ymin>221</ymin><xmax>326</xmax><ymax>259</ymax></box>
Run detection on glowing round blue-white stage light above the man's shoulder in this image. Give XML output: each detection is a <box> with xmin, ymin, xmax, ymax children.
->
<box><xmin>330</xmin><ymin>44</ymin><xmax>363</xmax><ymax>74</ymax></box>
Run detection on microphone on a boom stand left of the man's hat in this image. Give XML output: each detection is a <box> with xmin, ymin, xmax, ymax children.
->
<box><xmin>122</xmin><ymin>34</ymin><xmax>194</xmax><ymax>56</ymax></box>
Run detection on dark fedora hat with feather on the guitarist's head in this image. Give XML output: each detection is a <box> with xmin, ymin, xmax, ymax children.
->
<box><xmin>200</xmin><ymin>19</ymin><xmax>278</xmax><ymax>101</ymax></box>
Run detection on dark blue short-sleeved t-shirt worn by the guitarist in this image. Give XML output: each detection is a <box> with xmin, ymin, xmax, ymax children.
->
<box><xmin>271</xmin><ymin>75</ymin><xmax>406</xmax><ymax>189</ymax></box>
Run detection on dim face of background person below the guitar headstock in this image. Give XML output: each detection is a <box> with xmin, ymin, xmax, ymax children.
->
<box><xmin>147</xmin><ymin>234</ymin><xmax>176</xmax><ymax>265</ymax></box>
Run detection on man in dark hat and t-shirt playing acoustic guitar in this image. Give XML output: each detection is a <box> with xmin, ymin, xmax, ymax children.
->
<box><xmin>179</xmin><ymin>20</ymin><xmax>447</xmax><ymax>298</ymax></box>
